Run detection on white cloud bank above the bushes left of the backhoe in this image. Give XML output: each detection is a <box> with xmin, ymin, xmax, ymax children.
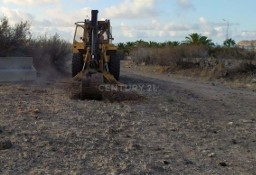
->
<box><xmin>0</xmin><ymin>6</ymin><xmax>91</xmax><ymax>41</ymax></box>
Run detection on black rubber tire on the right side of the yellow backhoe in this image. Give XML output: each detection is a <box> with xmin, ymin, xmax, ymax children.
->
<box><xmin>108</xmin><ymin>52</ymin><xmax>120</xmax><ymax>80</ymax></box>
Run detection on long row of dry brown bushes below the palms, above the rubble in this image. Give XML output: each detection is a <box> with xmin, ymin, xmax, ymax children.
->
<box><xmin>131</xmin><ymin>45</ymin><xmax>256</xmax><ymax>67</ymax></box>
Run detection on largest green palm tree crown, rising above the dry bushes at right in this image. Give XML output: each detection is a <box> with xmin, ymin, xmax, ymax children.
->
<box><xmin>184</xmin><ymin>33</ymin><xmax>214</xmax><ymax>46</ymax></box>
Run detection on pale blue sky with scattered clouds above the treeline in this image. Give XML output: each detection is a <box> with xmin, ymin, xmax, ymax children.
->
<box><xmin>0</xmin><ymin>0</ymin><xmax>256</xmax><ymax>44</ymax></box>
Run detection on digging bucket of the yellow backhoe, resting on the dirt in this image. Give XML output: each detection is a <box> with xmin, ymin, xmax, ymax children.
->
<box><xmin>81</xmin><ymin>72</ymin><xmax>104</xmax><ymax>100</ymax></box>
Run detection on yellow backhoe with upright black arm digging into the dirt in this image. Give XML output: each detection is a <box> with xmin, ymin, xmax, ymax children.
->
<box><xmin>72</xmin><ymin>10</ymin><xmax>121</xmax><ymax>100</ymax></box>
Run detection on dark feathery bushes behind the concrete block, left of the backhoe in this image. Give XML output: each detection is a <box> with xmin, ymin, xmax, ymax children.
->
<box><xmin>0</xmin><ymin>17</ymin><xmax>72</xmax><ymax>71</ymax></box>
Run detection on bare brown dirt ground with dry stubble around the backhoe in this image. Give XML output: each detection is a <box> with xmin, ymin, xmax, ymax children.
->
<box><xmin>0</xmin><ymin>60</ymin><xmax>256</xmax><ymax>175</ymax></box>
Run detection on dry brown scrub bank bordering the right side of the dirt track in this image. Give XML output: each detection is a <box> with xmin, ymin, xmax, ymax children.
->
<box><xmin>131</xmin><ymin>44</ymin><xmax>256</xmax><ymax>81</ymax></box>
